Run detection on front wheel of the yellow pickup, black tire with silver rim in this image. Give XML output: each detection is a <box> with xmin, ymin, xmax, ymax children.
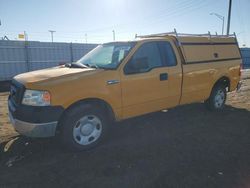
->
<box><xmin>60</xmin><ymin>104</ymin><xmax>109</xmax><ymax>151</ymax></box>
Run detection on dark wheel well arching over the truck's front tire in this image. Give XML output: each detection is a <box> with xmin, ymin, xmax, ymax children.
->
<box><xmin>57</xmin><ymin>98</ymin><xmax>116</xmax><ymax>131</ymax></box>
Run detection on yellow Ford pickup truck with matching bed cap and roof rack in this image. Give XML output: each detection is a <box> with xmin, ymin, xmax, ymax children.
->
<box><xmin>8</xmin><ymin>33</ymin><xmax>242</xmax><ymax>150</ymax></box>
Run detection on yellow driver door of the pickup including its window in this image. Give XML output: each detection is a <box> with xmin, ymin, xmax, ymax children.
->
<box><xmin>121</xmin><ymin>41</ymin><xmax>169</xmax><ymax>118</ymax></box>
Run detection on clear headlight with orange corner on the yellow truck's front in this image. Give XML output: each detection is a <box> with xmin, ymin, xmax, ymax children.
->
<box><xmin>22</xmin><ymin>89</ymin><xmax>50</xmax><ymax>106</ymax></box>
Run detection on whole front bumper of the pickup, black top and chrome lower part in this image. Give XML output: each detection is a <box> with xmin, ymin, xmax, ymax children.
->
<box><xmin>8</xmin><ymin>98</ymin><xmax>64</xmax><ymax>138</ymax></box>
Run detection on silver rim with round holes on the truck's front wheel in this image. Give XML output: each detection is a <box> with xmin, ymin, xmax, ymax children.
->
<box><xmin>73</xmin><ymin>115</ymin><xmax>102</xmax><ymax>145</ymax></box>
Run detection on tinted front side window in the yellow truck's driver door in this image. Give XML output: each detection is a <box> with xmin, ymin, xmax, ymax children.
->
<box><xmin>124</xmin><ymin>42</ymin><xmax>162</xmax><ymax>74</ymax></box>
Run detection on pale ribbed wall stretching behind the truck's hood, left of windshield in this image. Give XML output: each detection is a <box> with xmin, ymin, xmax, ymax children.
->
<box><xmin>0</xmin><ymin>40</ymin><xmax>97</xmax><ymax>81</ymax></box>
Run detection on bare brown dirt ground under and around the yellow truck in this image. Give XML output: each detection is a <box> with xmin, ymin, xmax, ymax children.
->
<box><xmin>0</xmin><ymin>79</ymin><xmax>250</xmax><ymax>188</ymax></box>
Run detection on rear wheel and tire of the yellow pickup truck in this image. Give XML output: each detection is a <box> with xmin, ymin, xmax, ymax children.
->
<box><xmin>205</xmin><ymin>84</ymin><xmax>227</xmax><ymax>111</ymax></box>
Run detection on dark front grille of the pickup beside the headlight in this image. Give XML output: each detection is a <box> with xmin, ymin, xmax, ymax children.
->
<box><xmin>10</xmin><ymin>80</ymin><xmax>25</xmax><ymax>105</ymax></box>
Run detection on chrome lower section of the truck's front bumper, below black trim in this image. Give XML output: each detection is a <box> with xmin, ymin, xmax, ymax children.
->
<box><xmin>9</xmin><ymin>111</ymin><xmax>57</xmax><ymax>138</ymax></box>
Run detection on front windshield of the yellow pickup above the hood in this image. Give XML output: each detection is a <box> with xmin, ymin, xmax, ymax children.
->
<box><xmin>76</xmin><ymin>42</ymin><xmax>135</xmax><ymax>69</ymax></box>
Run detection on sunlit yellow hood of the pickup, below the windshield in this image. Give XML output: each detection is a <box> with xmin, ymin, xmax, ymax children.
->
<box><xmin>14</xmin><ymin>66</ymin><xmax>97</xmax><ymax>85</ymax></box>
